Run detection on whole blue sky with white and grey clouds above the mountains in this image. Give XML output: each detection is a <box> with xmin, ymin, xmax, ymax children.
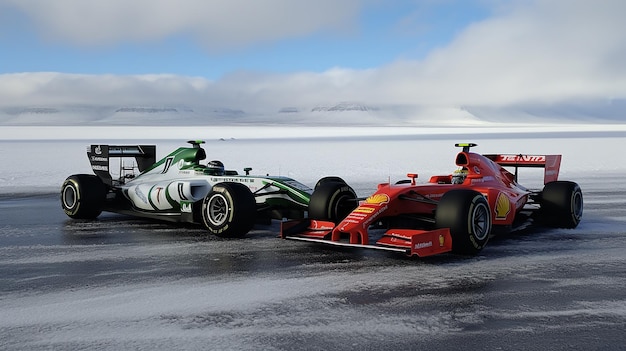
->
<box><xmin>0</xmin><ymin>0</ymin><xmax>626</xmax><ymax>120</ymax></box>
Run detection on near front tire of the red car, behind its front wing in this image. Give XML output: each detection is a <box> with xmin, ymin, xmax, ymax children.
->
<box><xmin>435</xmin><ymin>189</ymin><xmax>492</xmax><ymax>255</ymax></box>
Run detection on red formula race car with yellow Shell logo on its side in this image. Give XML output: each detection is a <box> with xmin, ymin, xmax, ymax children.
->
<box><xmin>281</xmin><ymin>143</ymin><xmax>583</xmax><ymax>257</ymax></box>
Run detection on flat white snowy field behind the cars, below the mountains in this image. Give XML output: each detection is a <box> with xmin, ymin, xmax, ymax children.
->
<box><xmin>0</xmin><ymin>125</ymin><xmax>626</xmax><ymax>194</ymax></box>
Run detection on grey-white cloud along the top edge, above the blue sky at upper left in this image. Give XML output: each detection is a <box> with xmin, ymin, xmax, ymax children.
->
<box><xmin>0</xmin><ymin>0</ymin><xmax>362</xmax><ymax>50</ymax></box>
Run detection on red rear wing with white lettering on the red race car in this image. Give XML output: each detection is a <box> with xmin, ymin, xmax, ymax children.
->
<box><xmin>483</xmin><ymin>154</ymin><xmax>561</xmax><ymax>184</ymax></box>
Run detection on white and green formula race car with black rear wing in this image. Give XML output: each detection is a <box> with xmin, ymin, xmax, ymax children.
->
<box><xmin>61</xmin><ymin>141</ymin><xmax>357</xmax><ymax>237</ymax></box>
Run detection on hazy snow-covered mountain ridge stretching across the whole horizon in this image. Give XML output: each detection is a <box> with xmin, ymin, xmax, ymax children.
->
<box><xmin>0</xmin><ymin>100</ymin><xmax>626</xmax><ymax>126</ymax></box>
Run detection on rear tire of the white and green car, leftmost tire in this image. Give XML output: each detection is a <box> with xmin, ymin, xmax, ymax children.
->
<box><xmin>61</xmin><ymin>174</ymin><xmax>107</xmax><ymax>219</ymax></box>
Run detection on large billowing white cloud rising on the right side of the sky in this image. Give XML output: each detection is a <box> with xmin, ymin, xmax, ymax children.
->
<box><xmin>368</xmin><ymin>1</ymin><xmax>626</xmax><ymax>105</ymax></box>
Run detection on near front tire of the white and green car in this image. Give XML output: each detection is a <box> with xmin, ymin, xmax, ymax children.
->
<box><xmin>201</xmin><ymin>182</ymin><xmax>256</xmax><ymax>238</ymax></box>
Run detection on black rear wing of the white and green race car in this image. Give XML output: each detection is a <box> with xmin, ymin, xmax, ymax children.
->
<box><xmin>87</xmin><ymin>145</ymin><xmax>156</xmax><ymax>186</ymax></box>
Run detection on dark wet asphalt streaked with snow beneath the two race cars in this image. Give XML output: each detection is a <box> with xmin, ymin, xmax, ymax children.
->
<box><xmin>0</xmin><ymin>177</ymin><xmax>626</xmax><ymax>350</ymax></box>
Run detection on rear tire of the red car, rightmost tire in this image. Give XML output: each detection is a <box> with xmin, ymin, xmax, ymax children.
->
<box><xmin>540</xmin><ymin>181</ymin><xmax>583</xmax><ymax>228</ymax></box>
